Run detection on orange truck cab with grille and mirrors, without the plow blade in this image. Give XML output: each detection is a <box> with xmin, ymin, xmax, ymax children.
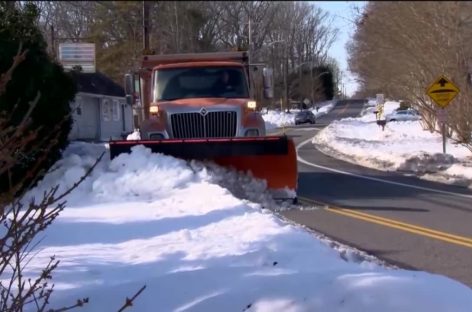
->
<box><xmin>126</xmin><ymin>52</ymin><xmax>272</xmax><ymax>140</ymax></box>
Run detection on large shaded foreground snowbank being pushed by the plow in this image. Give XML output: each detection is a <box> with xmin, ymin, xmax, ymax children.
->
<box><xmin>10</xmin><ymin>143</ymin><xmax>472</xmax><ymax>312</ymax></box>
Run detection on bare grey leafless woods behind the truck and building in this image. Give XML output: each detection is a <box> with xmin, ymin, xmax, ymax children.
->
<box><xmin>34</xmin><ymin>1</ymin><xmax>338</xmax><ymax>108</ymax></box>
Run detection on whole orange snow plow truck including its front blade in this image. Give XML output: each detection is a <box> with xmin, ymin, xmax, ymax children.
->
<box><xmin>109</xmin><ymin>51</ymin><xmax>298</xmax><ymax>202</ymax></box>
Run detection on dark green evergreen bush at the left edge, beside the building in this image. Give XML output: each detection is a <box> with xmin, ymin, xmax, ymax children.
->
<box><xmin>0</xmin><ymin>1</ymin><xmax>77</xmax><ymax>191</ymax></box>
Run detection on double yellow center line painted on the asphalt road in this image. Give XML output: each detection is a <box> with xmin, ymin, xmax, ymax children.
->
<box><xmin>300</xmin><ymin>198</ymin><xmax>472</xmax><ymax>248</ymax></box>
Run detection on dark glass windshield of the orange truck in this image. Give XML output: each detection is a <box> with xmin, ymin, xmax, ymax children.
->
<box><xmin>154</xmin><ymin>67</ymin><xmax>249</xmax><ymax>101</ymax></box>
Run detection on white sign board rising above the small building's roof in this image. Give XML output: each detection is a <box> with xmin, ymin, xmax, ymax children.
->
<box><xmin>59</xmin><ymin>43</ymin><xmax>95</xmax><ymax>73</ymax></box>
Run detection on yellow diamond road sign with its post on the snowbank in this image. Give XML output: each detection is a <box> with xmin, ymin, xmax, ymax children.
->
<box><xmin>426</xmin><ymin>76</ymin><xmax>460</xmax><ymax>154</ymax></box>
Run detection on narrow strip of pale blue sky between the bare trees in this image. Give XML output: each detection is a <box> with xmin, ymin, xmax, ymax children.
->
<box><xmin>311</xmin><ymin>1</ymin><xmax>367</xmax><ymax>95</ymax></box>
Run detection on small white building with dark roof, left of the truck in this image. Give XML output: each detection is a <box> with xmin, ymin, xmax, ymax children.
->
<box><xmin>69</xmin><ymin>72</ymin><xmax>134</xmax><ymax>141</ymax></box>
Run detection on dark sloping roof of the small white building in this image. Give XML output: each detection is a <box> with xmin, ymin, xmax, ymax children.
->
<box><xmin>71</xmin><ymin>72</ymin><xmax>125</xmax><ymax>97</ymax></box>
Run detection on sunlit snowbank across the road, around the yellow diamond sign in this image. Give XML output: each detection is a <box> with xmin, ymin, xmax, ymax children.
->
<box><xmin>313</xmin><ymin>101</ymin><xmax>472</xmax><ymax>187</ymax></box>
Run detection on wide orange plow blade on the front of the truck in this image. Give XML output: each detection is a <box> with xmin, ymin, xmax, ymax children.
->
<box><xmin>109</xmin><ymin>136</ymin><xmax>298</xmax><ymax>191</ymax></box>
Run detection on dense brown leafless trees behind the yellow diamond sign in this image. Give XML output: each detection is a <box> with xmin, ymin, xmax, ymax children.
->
<box><xmin>349</xmin><ymin>2</ymin><xmax>472</xmax><ymax>148</ymax></box>
